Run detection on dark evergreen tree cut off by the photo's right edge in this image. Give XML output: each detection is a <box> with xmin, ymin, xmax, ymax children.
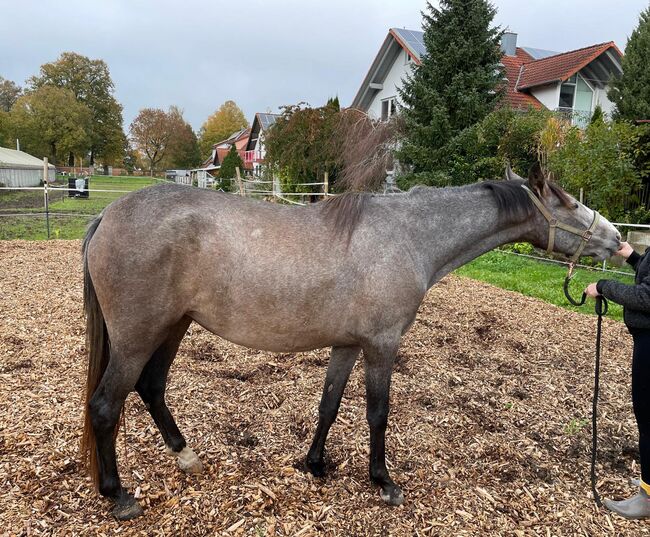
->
<box><xmin>608</xmin><ymin>7</ymin><xmax>650</xmax><ymax>120</ymax></box>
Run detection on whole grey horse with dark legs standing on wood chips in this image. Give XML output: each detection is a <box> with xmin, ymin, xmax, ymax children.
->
<box><xmin>82</xmin><ymin>165</ymin><xmax>620</xmax><ymax>519</ymax></box>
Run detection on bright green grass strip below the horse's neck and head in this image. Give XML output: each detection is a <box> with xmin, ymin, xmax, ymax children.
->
<box><xmin>455</xmin><ymin>250</ymin><xmax>634</xmax><ymax>320</ymax></box>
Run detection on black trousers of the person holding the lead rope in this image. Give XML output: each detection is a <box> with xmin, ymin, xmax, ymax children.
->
<box><xmin>632</xmin><ymin>330</ymin><xmax>650</xmax><ymax>484</ymax></box>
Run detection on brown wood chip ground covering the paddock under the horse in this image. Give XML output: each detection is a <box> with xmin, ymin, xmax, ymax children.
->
<box><xmin>0</xmin><ymin>241</ymin><xmax>650</xmax><ymax>537</ymax></box>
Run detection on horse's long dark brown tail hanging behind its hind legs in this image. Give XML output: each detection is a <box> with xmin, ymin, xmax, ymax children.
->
<box><xmin>81</xmin><ymin>214</ymin><xmax>110</xmax><ymax>486</ymax></box>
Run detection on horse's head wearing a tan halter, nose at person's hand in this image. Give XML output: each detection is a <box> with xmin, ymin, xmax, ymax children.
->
<box><xmin>506</xmin><ymin>165</ymin><xmax>621</xmax><ymax>261</ymax></box>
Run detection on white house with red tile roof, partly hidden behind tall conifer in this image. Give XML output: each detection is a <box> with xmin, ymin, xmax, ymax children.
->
<box><xmin>352</xmin><ymin>28</ymin><xmax>622</xmax><ymax>125</ymax></box>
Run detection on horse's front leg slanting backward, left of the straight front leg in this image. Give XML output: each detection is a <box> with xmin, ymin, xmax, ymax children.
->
<box><xmin>305</xmin><ymin>347</ymin><xmax>361</xmax><ymax>477</ymax></box>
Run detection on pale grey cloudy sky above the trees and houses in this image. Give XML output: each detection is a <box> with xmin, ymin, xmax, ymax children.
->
<box><xmin>0</xmin><ymin>0</ymin><xmax>648</xmax><ymax>129</ymax></box>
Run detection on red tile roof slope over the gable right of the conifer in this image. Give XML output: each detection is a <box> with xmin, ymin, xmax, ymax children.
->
<box><xmin>517</xmin><ymin>41</ymin><xmax>622</xmax><ymax>91</ymax></box>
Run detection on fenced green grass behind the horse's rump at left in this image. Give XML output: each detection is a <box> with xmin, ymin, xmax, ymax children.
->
<box><xmin>0</xmin><ymin>175</ymin><xmax>161</xmax><ymax>240</ymax></box>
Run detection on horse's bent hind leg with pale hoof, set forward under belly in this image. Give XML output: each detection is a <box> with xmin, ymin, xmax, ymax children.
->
<box><xmin>135</xmin><ymin>317</ymin><xmax>203</xmax><ymax>473</ymax></box>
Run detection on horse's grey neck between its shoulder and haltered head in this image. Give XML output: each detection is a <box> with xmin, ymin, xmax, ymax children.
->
<box><xmin>402</xmin><ymin>186</ymin><xmax>529</xmax><ymax>286</ymax></box>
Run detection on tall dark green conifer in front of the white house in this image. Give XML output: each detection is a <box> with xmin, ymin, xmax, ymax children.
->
<box><xmin>398</xmin><ymin>0</ymin><xmax>504</xmax><ymax>185</ymax></box>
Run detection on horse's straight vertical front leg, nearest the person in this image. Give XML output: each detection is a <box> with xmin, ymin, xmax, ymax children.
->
<box><xmin>363</xmin><ymin>340</ymin><xmax>404</xmax><ymax>505</ymax></box>
